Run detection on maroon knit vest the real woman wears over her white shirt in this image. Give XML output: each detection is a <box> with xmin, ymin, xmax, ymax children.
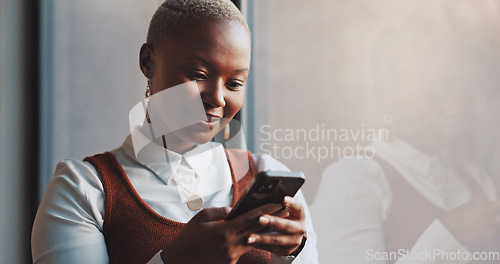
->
<box><xmin>84</xmin><ymin>149</ymin><xmax>271</xmax><ymax>264</ymax></box>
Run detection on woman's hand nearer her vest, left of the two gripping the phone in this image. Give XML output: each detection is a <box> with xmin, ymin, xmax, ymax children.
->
<box><xmin>161</xmin><ymin>204</ymin><xmax>282</xmax><ymax>264</ymax></box>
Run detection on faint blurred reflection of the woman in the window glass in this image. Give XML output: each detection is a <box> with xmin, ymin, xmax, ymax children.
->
<box><xmin>311</xmin><ymin>17</ymin><xmax>500</xmax><ymax>263</ymax></box>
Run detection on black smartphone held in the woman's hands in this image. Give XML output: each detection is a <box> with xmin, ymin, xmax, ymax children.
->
<box><xmin>226</xmin><ymin>171</ymin><xmax>305</xmax><ymax>220</ymax></box>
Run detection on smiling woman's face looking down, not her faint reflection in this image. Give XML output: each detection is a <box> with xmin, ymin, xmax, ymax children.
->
<box><xmin>140</xmin><ymin>20</ymin><xmax>251</xmax><ymax>152</ymax></box>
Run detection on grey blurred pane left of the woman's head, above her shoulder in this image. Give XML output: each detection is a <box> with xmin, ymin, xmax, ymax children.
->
<box><xmin>41</xmin><ymin>0</ymin><xmax>159</xmax><ymax>193</ymax></box>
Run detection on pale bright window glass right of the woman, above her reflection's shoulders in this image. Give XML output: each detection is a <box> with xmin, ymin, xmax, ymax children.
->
<box><xmin>251</xmin><ymin>0</ymin><xmax>500</xmax><ymax>201</ymax></box>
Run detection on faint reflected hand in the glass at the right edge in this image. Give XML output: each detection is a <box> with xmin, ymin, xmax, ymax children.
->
<box><xmin>440</xmin><ymin>201</ymin><xmax>500</xmax><ymax>251</ymax></box>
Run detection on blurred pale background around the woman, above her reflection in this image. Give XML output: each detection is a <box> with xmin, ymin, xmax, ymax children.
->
<box><xmin>0</xmin><ymin>0</ymin><xmax>500</xmax><ymax>263</ymax></box>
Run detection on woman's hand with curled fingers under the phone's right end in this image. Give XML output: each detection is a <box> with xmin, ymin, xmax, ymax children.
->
<box><xmin>248</xmin><ymin>196</ymin><xmax>306</xmax><ymax>256</ymax></box>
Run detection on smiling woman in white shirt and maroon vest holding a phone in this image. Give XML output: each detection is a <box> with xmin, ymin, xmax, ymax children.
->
<box><xmin>32</xmin><ymin>0</ymin><xmax>316</xmax><ymax>263</ymax></box>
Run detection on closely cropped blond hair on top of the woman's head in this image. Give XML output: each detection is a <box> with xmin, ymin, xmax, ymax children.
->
<box><xmin>146</xmin><ymin>0</ymin><xmax>250</xmax><ymax>47</ymax></box>
